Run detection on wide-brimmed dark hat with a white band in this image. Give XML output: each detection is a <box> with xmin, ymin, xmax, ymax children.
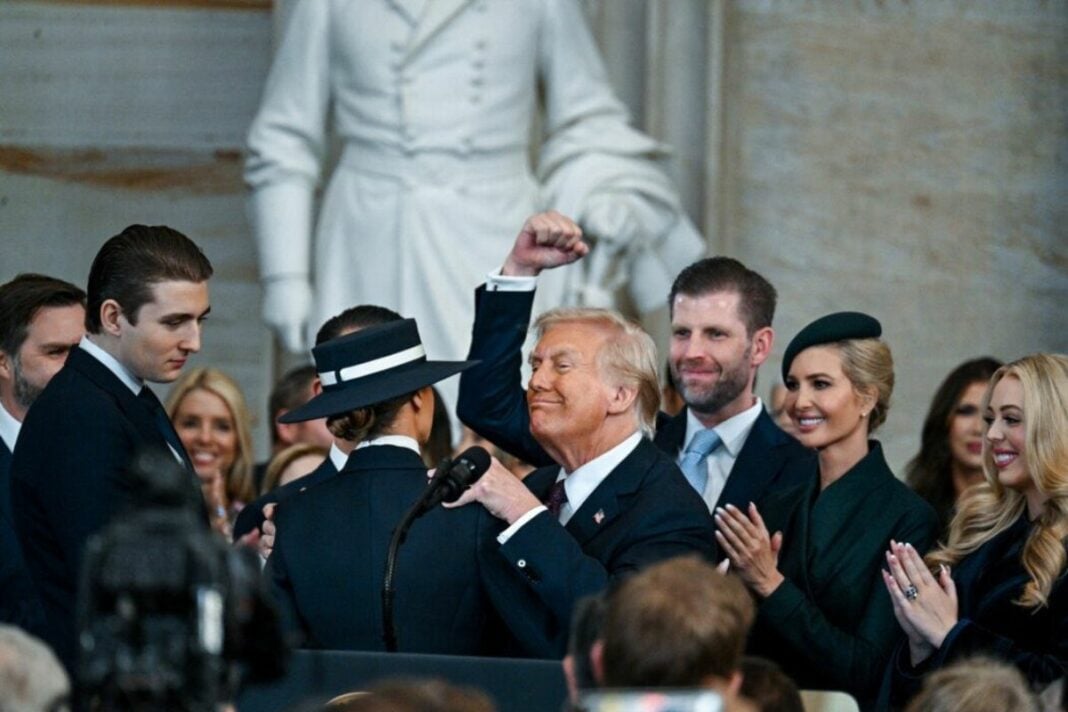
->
<box><xmin>278</xmin><ymin>319</ymin><xmax>478</xmax><ymax>423</ymax></box>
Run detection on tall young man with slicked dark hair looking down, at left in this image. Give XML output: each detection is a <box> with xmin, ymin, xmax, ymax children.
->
<box><xmin>12</xmin><ymin>225</ymin><xmax>211</xmax><ymax>669</ymax></box>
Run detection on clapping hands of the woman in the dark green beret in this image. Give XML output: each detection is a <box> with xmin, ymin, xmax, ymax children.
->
<box><xmin>716</xmin><ymin>503</ymin><xmax>784</xmax><ymax>598</ymax></box>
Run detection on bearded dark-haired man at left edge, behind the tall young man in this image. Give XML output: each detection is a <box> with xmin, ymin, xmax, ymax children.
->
<box><xmin>0</xmin><ymin>274</ymin><xmax>85</xmax><ymax>632</ymax></box>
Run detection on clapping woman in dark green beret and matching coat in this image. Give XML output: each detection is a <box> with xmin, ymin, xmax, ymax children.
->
<box><xmin>717</xmin><ymin>312</ymin><xmax>938</xmax><ymax>709</ymax></box>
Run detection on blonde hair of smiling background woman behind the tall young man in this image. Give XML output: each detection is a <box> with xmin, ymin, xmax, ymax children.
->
<box><xmin>166</xmin><ymin>366</ymin><xmax>256</xmax><ymax>504</ymax></box>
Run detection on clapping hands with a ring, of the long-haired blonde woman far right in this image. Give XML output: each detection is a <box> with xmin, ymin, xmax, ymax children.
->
<box><xmin>882</xmin><ymin>541</ymin><xmax>958</xmax><ymax>665</ymax></box>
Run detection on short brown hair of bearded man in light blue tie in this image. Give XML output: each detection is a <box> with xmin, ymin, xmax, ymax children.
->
<box><xmin>668</xmin><ymin>256</ymin><xmax>779</xmax><ymax>336</ymax></box>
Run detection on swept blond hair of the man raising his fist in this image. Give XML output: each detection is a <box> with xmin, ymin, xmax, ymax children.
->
<box><xmin>534</xmin><ymin>306</ymin><xmax>660</xmax><ymax>438</ymax></box>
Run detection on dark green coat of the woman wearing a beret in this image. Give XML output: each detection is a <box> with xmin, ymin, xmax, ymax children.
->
<box><xmin>749</xmin><ymin>441</ymin><xmax>938</xmax><ymax>709</ymax></box>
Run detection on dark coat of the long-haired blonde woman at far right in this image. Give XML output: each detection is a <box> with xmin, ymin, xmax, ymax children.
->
<box><xmin>880</xmin><ymin>515</ymin><xmax>1068</xmax><ymax>708</ymax></box>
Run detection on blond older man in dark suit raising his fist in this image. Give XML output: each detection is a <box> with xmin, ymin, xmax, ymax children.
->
<box><xmin>446</xmin><ymin>213</ymin><xmax>713</xmax><ymax>655</ymax></box>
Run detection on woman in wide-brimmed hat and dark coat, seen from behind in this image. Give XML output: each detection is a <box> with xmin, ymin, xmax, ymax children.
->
<box><xmin>266</xmin><ymin>319</ymin><xmax>502</xmax><ymax>655</ymax></box>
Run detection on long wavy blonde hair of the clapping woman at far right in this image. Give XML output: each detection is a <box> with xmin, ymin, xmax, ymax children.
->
<box><xmin>925</xmin><ymin>353</ymin><xmax>1068</xmax><ymax>607</ymax></box>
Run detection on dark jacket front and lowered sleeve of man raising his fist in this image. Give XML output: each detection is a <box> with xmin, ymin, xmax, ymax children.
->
<box><xmin>500</xmin><ymin>440</ymin><xmax>714</xmax><ymax>658</ymax></box>
